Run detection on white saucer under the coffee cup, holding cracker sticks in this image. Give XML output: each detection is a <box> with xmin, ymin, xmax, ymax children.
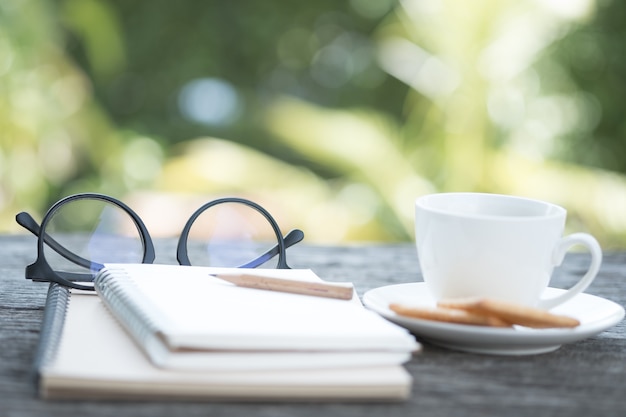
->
<box><xmin>363</xmin><ymin>282</ymin><xmax>624</xmax><ymax>355</ymax></box>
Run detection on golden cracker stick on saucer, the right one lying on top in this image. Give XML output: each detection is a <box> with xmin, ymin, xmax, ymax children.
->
<box><xmin>438</xmin><ymin>298</ymin><xmax>580</xmax><ymax>329</ymax></box>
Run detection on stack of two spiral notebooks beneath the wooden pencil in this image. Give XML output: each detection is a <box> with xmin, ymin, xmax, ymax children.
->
<box><xmin>38</xmin><ymin>264</ymin><xmax>420</xmax><ymax>401</ymax></box>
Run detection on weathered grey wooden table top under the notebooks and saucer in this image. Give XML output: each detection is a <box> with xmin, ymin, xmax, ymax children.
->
<box><xmin>0</xmin><ymin>236</ymin><xmax>626</xmax><ymax>417</ymax></box>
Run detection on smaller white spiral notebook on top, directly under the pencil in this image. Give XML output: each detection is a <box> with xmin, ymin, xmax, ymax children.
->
<box><xmin>90</xmin><ymin>264</ymin><xmax>419</xmax><ymax>370</ymax></box>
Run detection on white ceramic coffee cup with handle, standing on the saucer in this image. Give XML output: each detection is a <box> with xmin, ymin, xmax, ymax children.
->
<box><xmin>415</xmin><ymin>193</ymin><xmax>602</xmax><ymax>309</ymax></box>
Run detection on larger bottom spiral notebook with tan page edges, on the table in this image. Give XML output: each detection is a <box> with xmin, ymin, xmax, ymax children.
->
<box><xmin>35</xmin><ymin>264</ymin><xmax>412</xmax><ymax>401</ymax></box>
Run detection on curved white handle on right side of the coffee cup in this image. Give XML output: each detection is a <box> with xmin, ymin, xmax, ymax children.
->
<box><xmin>537</xmin><ymin>233</ymin><xmax>602</xmax><ymax>310</ymax></box>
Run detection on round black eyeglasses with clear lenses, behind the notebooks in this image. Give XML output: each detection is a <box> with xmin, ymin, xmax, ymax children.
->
<box><xmin>15</xmin><ymin>193</ymin><xmax>304</xmax><ymax>290</ymax></box>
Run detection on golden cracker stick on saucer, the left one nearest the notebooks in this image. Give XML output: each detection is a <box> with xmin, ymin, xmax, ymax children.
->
<box><xmin>389</xmin><ymin>303</ymin><xmax>511</xmax><ymax>327</ymax></box>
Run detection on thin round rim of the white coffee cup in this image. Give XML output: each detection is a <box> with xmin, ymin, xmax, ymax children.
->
<box><xmin>415</xmin><ymin>192</ymin><xmax>567</xmax><ymax>221</ymax></box>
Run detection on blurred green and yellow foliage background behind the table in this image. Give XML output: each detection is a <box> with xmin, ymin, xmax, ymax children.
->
<box><xmin>0</xmin><ymin>0</ymin><xmax>626</xmax><ymax>248</ymax></box>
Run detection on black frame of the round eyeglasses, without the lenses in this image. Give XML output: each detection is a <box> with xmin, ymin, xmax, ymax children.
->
<box><xmin>15</xmin><ymin>193</ymin><xmax>304</xmax><ymax>291</ymax></box>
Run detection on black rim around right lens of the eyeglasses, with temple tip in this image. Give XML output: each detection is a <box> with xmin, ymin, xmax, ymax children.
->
<box><xmin>176</xmin><ymin>197</ymin><xmax>294</xmax><ymax>269</ymax></box>
